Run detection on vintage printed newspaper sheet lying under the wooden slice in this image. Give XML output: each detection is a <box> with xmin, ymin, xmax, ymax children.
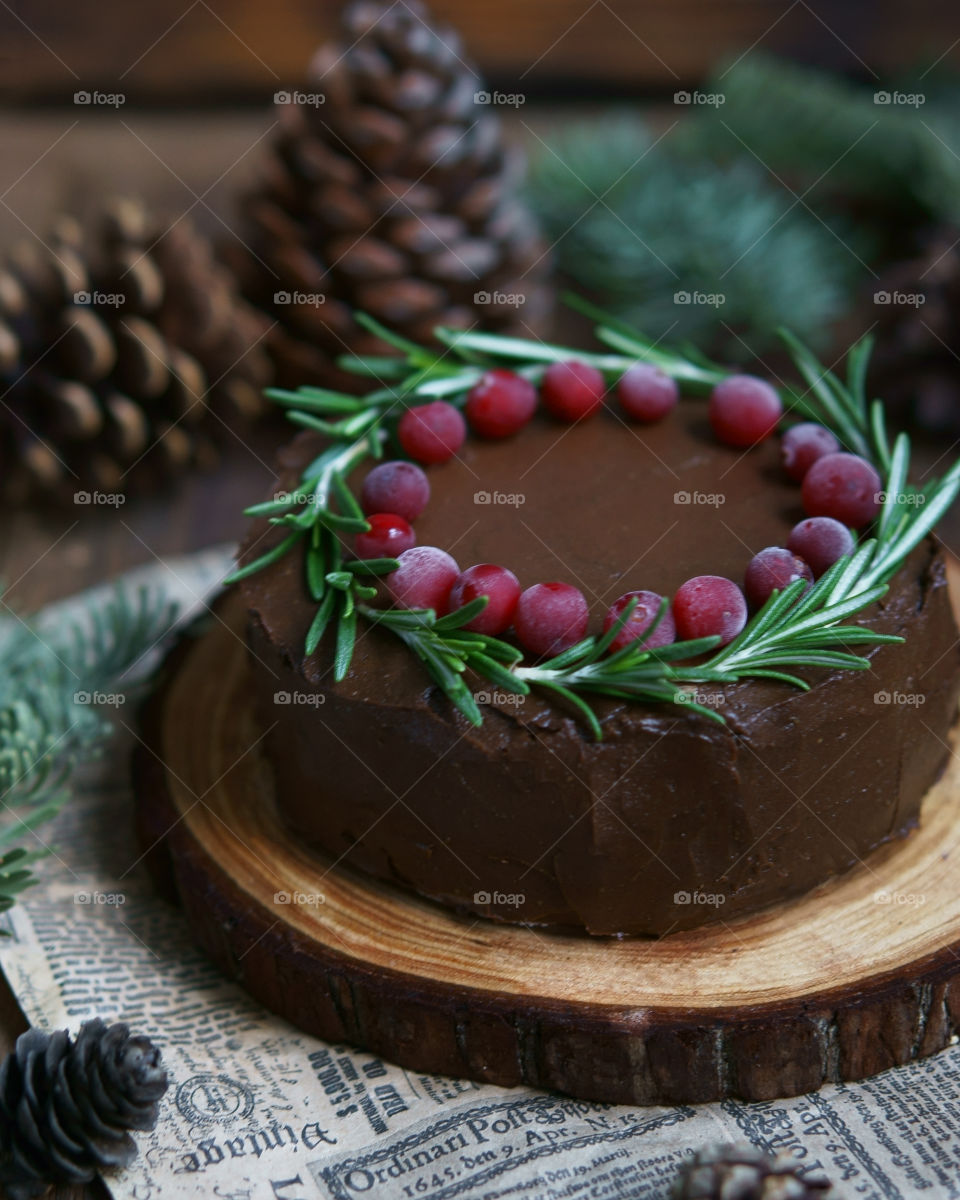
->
<box><xmin>0</xmin><ymin>551</ymin><xmax>960</xmax><ymax>1200</ymax></box>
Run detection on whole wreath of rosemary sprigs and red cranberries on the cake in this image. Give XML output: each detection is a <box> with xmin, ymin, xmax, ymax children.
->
<box><xmin>227</xmin><ymin>298</ymin><xmax>960</xmax><ymax>739</ymax></box>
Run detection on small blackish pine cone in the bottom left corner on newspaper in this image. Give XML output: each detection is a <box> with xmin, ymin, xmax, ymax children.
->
<box><xmin>0</xmin><ymin>1019</ymin><xmax>168</xmax><ymax>1200</ymax></box>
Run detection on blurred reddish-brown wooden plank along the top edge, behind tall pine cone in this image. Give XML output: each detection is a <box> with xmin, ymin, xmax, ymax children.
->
<box><xmin>0</xmin><ymin>0</ymin><xmax>960</xmax><ymax>106</ymax></box>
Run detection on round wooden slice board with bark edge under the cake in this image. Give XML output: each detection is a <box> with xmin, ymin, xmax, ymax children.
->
<box><xmin>136</xmin><ymin>590</ymin><xmax>960</xmax><ymax>1104</ymax></box>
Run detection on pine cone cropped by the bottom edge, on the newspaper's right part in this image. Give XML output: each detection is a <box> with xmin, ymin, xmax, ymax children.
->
<box><xmin>671</xmin><ymin>1142</ymin><xmax>840</xmax><ymax>1200</ymax></box>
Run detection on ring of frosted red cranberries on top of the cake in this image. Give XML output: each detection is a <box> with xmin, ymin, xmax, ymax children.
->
<box><xmin>356</xmin><ymin>361</ymin><xmax>881</xmax><ymax>658</ymax></box>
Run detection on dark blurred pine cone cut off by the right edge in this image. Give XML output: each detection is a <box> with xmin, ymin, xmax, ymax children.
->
<box><xmin>869</xmin><ymin>226</ymin><xmax>960</xmax><ymax>436</ymax></box>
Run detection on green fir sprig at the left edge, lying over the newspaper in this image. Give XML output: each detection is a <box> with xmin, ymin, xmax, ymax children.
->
<box><xmin>0</xmin><ymin>588</ymin><xmax>176</xmax><ymax>912</ymax></box>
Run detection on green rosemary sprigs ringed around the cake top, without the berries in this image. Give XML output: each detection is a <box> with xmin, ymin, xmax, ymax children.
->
<box><xmin>228</xmin><ymin>298</ymin><xmax>960</xmax><ymax>738</ymax></box>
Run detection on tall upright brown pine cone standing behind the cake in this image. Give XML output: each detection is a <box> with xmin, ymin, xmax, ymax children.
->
<box><xmin>232</xmin><ymin>0</ymin><xmax>548</xmax><ymax>386</ymax></box>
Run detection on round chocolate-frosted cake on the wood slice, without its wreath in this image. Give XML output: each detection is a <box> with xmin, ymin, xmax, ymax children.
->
<box><xmin>242</xmin><ymin>401</ymin><xmax>960</xmax><ymax>936</ymax></box>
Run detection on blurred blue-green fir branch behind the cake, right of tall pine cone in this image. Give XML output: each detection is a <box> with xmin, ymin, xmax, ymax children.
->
<box><xmin>528</xmin><ymin>120</ymin><xmax>866</xmax><ymax>360</ymax></box>
